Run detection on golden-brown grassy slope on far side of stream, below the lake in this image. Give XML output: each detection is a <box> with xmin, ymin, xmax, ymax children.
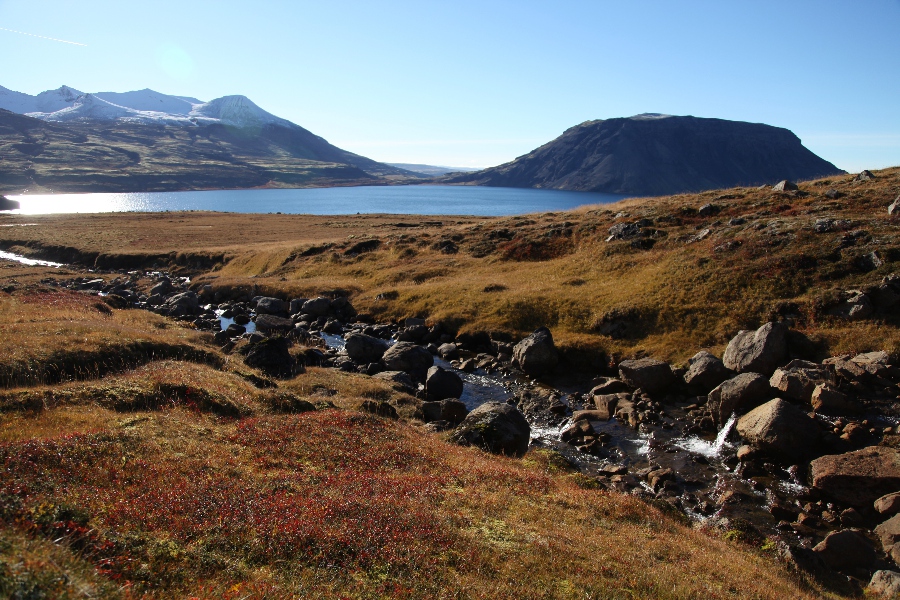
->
<box><xmin>7</xmin><ymin>168</ymin><xmax>900</xmax><ymax>361</ymax></box>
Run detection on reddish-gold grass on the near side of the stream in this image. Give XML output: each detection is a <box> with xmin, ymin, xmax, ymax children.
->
<box><xmin>0</xmin><ymin>280</ymin><xmax>844</xmax><ymax>598</ymax></box>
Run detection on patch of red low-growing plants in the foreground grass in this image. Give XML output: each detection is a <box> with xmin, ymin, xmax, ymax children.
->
<box><xmin>0</xmin><ymin>411</ymin><xmax>453</xmax><ymax>592</ymax></box>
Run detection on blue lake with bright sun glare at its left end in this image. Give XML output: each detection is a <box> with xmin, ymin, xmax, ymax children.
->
<box><xmin>8</xmin><ymin>185</ymin><xmax>625</xmax><ymax>216</ymax></box>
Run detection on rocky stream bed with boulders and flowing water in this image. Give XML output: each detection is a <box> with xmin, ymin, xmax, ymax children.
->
<box><xmin>28</xmin><ymin>272</ymin><xmax>900</xmax><ymax>595</ymax></box>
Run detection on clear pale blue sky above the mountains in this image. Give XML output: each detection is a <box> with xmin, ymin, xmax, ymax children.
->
<box><xmin>0</xmin><ymin>0</ymin><xmax>900</xmax><ymax>171</ymax></box>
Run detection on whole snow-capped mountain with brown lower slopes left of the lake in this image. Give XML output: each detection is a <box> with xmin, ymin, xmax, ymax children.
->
<box><xmin>0</xmin><ymin>86</ymin><xmax>423</xmax><ymax>193</ymax></box>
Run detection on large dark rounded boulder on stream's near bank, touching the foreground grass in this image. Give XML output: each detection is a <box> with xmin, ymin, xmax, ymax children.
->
<box><xmin>450</xmin><ymin>402</ymin><xmax>531</xmax><ymax>456</ymax></box>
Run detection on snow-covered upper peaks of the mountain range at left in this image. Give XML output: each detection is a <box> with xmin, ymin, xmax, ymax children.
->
<box><xmin>0</xmin><ymin>86</ymin><xmax>298</xmax><ymax>128</ymax></box>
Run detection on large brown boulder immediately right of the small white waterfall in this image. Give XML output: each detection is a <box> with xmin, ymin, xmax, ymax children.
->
<box><xmin>737</xmin><ymin>398</ymin><xmax>820</xmax><ymax>464</ymax></box>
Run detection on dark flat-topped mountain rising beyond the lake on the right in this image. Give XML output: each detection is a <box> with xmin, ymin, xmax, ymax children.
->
<box><xmin>445</xmin><ymin>116</ymin><xmax>843</xmax><ymax>196</ymax></box>
